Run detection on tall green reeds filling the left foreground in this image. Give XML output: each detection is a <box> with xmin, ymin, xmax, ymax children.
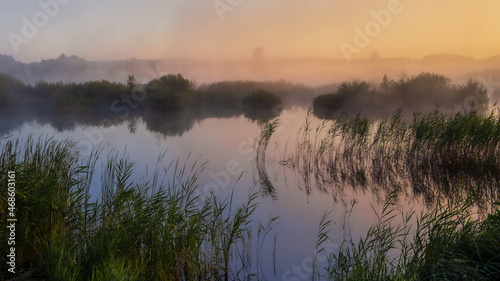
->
<box><xmin>0</xmin><ymin>135</ymin><xmax>266</xmax><ymax>280</ymax></box>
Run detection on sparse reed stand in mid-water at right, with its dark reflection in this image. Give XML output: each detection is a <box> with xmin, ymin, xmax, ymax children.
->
<box><xmin>281</xmin><ymin>108</ymin><xmax>500</xmax><ymax>209</ymax></box>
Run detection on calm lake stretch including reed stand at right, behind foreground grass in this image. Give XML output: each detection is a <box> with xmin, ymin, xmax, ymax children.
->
<box><xmin>0</xmin><ymin>105</ymin><xmax>500</xmax><ymax>279</ymax></box>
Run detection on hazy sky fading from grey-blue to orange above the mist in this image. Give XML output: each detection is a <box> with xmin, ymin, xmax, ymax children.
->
<box><xmin>0</xmin><ymin>0</ymin><xmax>500</xmax><ymax>62</ymax></box>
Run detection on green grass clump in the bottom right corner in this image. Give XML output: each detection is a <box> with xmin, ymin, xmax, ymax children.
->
<box><xmin>327</xmin><ymin>196</ymin><xmax>500</xmax><ymax>280</ymax></box>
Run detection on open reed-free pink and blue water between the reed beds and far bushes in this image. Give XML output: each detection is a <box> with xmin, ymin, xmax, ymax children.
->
<box><xmin>0</xmin><ymin>107</ymin><xmax>496</xmax><ymax>280</ymax></box>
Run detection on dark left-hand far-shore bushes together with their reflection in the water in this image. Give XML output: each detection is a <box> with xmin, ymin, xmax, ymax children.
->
<box><xmin>0</xmin><ymin>73</ymin><xmax>292</xmax><ymax>136</ymax></box>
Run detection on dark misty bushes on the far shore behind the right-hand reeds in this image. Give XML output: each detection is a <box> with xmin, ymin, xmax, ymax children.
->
<box><xmin>313</xmin><ymin>72</ymin><xmax>489</xmax><ymax>118</ymax></box>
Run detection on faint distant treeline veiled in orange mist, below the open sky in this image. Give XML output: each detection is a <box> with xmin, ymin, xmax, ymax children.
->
<box><xmin>0</xmin><ymin>52</ymin><xmax>500</xmax><ymax>87</ymax></box>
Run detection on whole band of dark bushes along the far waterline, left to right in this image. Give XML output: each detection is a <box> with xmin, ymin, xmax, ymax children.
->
<box><xmin>0</xmin><ymin>70</ymin><xmax>489</xmax><ymax>121</ymax></box>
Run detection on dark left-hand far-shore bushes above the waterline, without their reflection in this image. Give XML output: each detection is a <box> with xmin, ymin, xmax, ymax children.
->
<box><xmin>0</xmin><ymin>71</ymin><xmax>290</xmax><ymax>121</ymax></box>
